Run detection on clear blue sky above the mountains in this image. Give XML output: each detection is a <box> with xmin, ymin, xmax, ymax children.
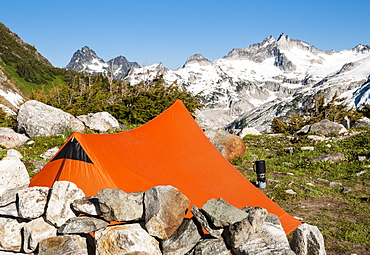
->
<box><xmin>0</xmin><ymin>0</ymin><xmax>370</xmax><ymax>69</ymax></box>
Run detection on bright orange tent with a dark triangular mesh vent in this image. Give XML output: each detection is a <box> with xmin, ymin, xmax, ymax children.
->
<box><xmin>30</xmin><ymin>100</ymin><xmax>301</xmax><ymax>234</ymax></box>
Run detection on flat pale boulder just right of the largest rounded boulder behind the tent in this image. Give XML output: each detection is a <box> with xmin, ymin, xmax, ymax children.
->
<box><xmin>77</xmin><ymin>112</ymin><xmax>121</xmax><ymax>132</ymax></box>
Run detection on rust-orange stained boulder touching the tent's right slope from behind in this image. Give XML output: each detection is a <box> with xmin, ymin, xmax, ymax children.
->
<box><xmin>205</xmin><ymin>130</ymin><xmax>246</xmax><ymax>161</ymax></box>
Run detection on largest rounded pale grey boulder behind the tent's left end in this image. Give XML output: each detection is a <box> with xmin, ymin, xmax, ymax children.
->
<box><xmin>17</xmin><ymin>100</ymin><xmax>85</xmax><ymax>137</ymax></box>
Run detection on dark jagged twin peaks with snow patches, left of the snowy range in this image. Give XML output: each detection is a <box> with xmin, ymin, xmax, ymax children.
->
<box><xmin>66</xmin><ymin>46</ymin><xmax>140</xmax><ymax>79</ymax></box>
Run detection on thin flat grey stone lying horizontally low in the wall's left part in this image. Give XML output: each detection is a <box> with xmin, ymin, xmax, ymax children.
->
<box><xmin>58</xmin><ymin>216</ymin><xmax>109</xmax><ymax>234</ymax></box>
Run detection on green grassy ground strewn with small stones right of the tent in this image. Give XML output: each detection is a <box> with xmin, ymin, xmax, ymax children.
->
<box><xmin>234</xmin><ymin>129</ymin><xmax>370</xmax><ymax>255</ymax></box>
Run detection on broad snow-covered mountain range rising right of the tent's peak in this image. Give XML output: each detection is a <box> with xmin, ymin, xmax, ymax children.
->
<box><xmin>125</xmin><ymin>34</ymin><xmax>370</xmax><ymax>133</ymax></box>
